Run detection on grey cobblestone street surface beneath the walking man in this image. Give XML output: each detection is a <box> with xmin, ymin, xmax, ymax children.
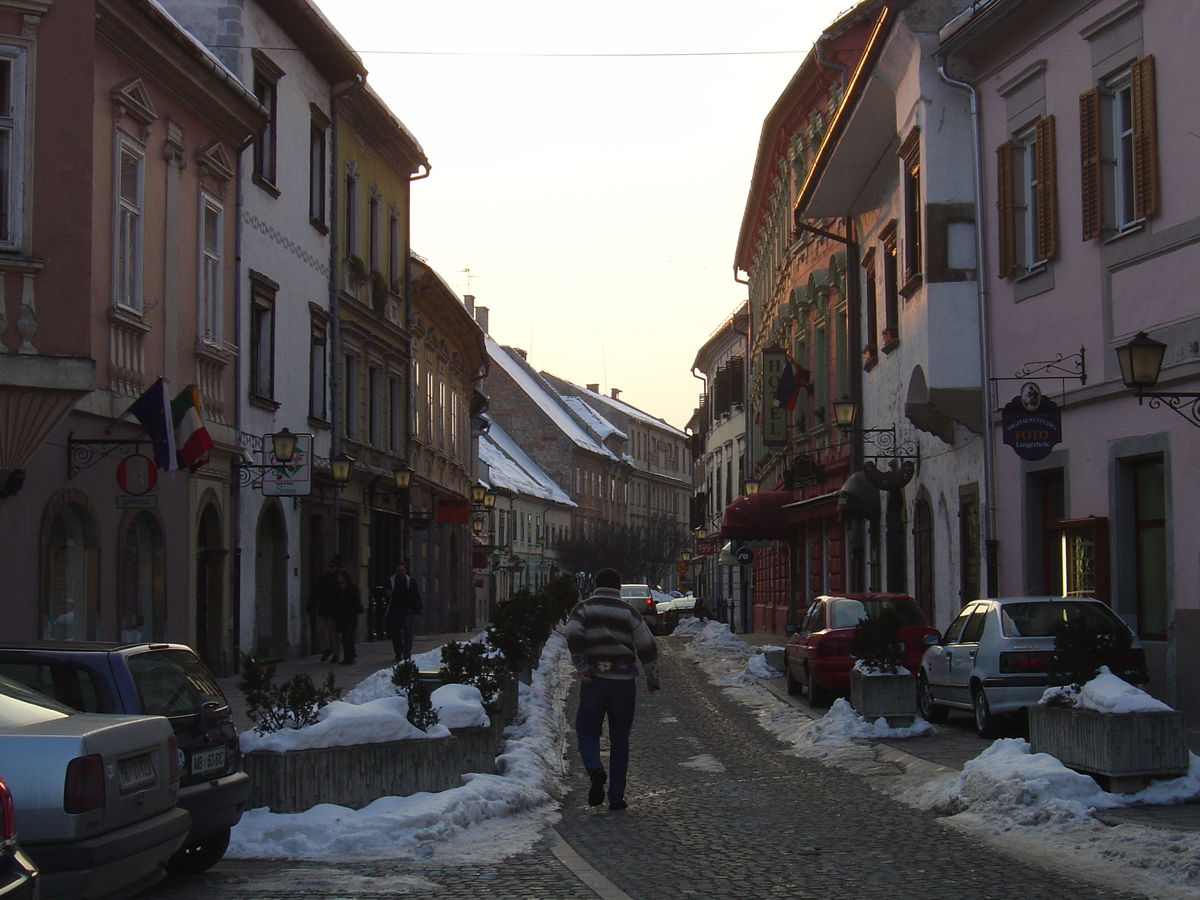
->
<box><xmin>143</xmin><ymin>640</ymin><xmax>1140</xmax><ymax>900</ymax></box>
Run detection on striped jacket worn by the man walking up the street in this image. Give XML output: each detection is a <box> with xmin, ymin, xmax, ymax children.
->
<box><xmin>565</xmin><ymin>588</ymin><xmax>659</xmax><ymax>688</ymax></box>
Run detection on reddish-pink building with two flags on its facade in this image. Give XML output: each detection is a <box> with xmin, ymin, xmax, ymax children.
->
<box><xmin>0</xmin><ymin>0</ymin><xmax>264</xmax><ymax>664</ymax></box>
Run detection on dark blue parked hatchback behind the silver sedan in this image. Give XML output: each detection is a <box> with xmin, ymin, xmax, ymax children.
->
<box><xmin>0</xmin><ymin>641</ymin><xmax>250</xmax><ymax>875</ymax></box>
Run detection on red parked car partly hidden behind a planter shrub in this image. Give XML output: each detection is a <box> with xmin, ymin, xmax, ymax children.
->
<box><xmin>784</xmin><ymin>594</ymin><xmax>937</xmax><ymax>706</ymax></box>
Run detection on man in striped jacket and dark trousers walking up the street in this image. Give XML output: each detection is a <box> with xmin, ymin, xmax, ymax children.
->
<box><xmin>566</xmin><ymin>569</ymin><xmax>659</xmax><ymax>811</ymax></box>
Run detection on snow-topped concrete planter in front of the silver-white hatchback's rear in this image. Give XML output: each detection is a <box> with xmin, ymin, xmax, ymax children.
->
<box><xmin>1030</xmin><ymin>704</ymin><xmax>1188</xmax><ymax>793</ymax></box>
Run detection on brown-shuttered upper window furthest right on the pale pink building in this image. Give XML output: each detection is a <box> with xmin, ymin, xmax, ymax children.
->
<box><xmin>1079</xmin><ymin>56</ymin><xmax>1158</xmax><ymax>240</ymax></box>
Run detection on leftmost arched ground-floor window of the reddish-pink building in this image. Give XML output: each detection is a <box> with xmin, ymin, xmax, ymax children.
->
<box><xmin>42</xmin><ymin>503</ymin><xmax>97</xmax><ymax>641</ymax></box>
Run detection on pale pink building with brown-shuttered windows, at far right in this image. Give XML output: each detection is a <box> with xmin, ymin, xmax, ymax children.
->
<box><xmin>941</xmin><ymin>0</ymin><xmax>1200</xmax><ymax>724</ymax></box>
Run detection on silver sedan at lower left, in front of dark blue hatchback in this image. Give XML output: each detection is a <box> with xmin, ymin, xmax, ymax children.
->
<box><xmin>0</xmin><ymin>677</ymin><xmax>192</xmax><ymax>900</ymax></box>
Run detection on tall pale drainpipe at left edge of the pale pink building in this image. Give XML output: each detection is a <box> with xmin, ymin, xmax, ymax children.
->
<box><xmin>937</xmin><ymin>61</ymin><xmax>1000</xmax><ymax>596</ymax></box>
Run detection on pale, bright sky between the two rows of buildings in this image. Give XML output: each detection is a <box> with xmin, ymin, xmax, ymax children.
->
<box><xmin>317</xmin><ymin>0</ymin><xmax>853</xmax><ymax>428</ymax></box>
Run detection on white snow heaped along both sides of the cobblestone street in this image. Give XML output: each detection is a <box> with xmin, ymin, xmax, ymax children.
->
<box><xmin>228</xmin><ymin>618</ymin><xmax>1200</xmax><ymax>898</ymax></box>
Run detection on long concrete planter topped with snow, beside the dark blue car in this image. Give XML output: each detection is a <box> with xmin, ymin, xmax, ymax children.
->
<box><xmin>245</xmin><ymin>716</ymin><xmax>504</xmax><ymax>812</ymax></box>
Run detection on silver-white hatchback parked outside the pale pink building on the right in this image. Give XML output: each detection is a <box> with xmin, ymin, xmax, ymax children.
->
<box><xmin>917</xmin><ymin>596</ymin><xmax>1148</xmax><ymax>737</ymax></box>
